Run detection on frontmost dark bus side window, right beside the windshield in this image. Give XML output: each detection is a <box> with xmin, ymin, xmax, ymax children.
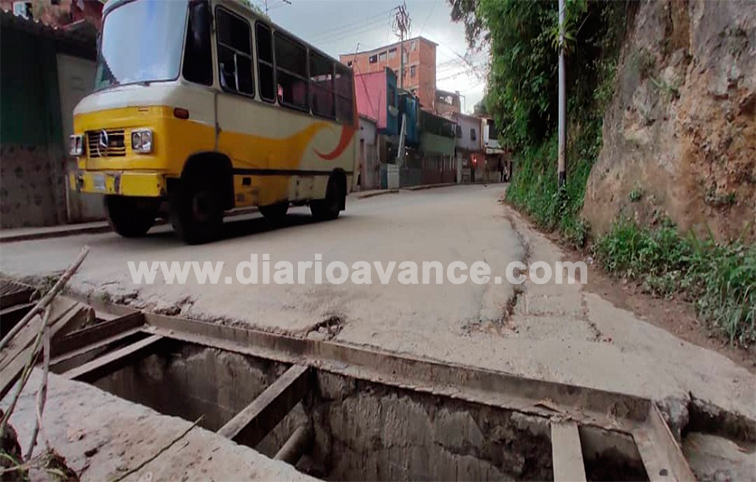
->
<box><xmin>183</xmin><ymin>1</ymin><xmax>213</xmax><ymax>85</ymax></box>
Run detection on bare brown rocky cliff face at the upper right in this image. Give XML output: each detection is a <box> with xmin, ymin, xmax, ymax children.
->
<box><xmin>583</xmin><ymin>0</ymin><xmax>756</xmax><ymax>241</ymax></box>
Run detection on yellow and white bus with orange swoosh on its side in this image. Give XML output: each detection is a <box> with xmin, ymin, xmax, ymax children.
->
<box><xmin>70</xmin><ymin>0</ymin><xmax>358</xmax><ymax>244</ymax></box>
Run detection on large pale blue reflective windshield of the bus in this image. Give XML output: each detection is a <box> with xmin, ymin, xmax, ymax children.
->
<box><xmin>95</xmin><ymin>0</ymin><xmax>187</xmax><ymax>90</ymax></box>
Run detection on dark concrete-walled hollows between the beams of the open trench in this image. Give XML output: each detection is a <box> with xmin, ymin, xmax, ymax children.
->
<box><xmin>85</xmin><ymin>342</ymin><xmax>648</xmax><ymax>480</ymax></box>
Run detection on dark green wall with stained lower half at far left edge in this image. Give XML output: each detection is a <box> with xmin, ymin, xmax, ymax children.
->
<box><xmin>0</xmin><ymin>28</ymin><xmax>66</xmax><ymax>228</ymax></box>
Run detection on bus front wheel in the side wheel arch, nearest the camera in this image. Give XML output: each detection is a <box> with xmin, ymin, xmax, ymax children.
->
<box><xmin>168</xmin><ymin>177</ymin><xmax>223</xmax><ymax>244</ymax></box>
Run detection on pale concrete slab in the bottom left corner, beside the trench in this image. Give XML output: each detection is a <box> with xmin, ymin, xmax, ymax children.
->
<box><xmin>0</xmin><ymin>370</ymin><xmax>316</xmax><ymax>481</ymax></box>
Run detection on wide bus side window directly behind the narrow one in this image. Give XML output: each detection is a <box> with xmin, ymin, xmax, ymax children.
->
<box><xmin>274</xmin><ymin>32</ymin><xmax>310</xmax><ymax>110</ymax></box>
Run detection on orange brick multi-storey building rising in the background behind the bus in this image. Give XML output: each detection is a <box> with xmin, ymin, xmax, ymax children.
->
<box><xmin>339</xmin><ymin>37</ymin><xmax>437</xmax><ymax>111</ymax></box>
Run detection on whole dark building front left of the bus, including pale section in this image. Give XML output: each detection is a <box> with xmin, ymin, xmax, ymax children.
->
<box><xmin>0</xmin><ymin>6</ymin><xmax>104</xmax><ymax>228</ymax></box>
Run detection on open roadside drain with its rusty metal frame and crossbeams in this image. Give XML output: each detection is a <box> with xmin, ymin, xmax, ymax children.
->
<box><xmin>0</xmin><ymin>290</ymin><xmax>692</xmax><ymax>481</ymax></box>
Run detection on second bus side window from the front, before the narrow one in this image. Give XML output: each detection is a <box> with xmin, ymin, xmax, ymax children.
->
<box><xmin>215</xmin><ymin>9</ymin><xmax>255</xmax><ymax>95</ymax></box>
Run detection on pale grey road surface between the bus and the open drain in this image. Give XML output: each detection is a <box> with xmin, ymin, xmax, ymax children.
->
<box><xmin>0</xmin><ymin>185</ymin><xmax>756</xmax><ymax>419</ymax></box>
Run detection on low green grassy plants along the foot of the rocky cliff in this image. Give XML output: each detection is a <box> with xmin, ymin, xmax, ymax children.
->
<box><xmin>594</xmin><ymin>218</ymin><xmax>756</xmax><ymax>346</ymax></box>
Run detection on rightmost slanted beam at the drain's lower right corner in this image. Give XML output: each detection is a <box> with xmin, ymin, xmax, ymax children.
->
<box><xmin>633</xmin><ymin>403</ymin><xmax>696</xmax><ymax>482</ymax></box>
